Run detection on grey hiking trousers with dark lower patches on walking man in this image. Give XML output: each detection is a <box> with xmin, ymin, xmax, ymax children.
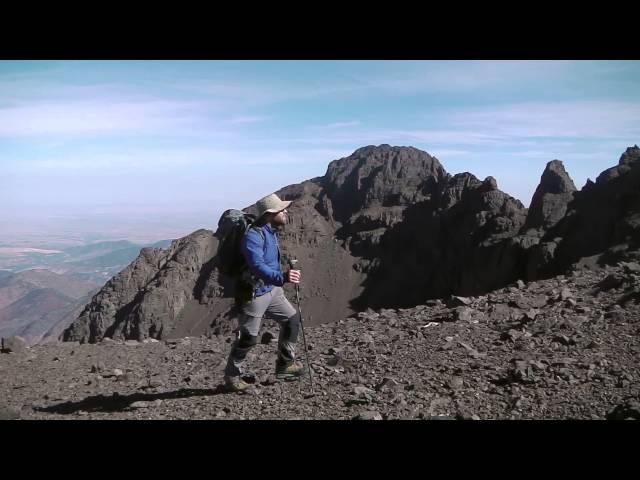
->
<box><xmin>224</xmin><ymin>287</ymin><xmax>300</xmax><ymax>377</ymax></box>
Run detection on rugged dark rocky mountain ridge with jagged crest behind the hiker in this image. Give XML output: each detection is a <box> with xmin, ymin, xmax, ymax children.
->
<box><xmin>64</xmin><ymin>145</ymin><xmax>640</xmax><ymax>342</ymax></box>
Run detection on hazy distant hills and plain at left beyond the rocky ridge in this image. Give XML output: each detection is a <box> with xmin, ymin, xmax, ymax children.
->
<box><xmin>0</xmin><ymin>240</ymin><xmax>171</xmax><ymax>344</ymax></box>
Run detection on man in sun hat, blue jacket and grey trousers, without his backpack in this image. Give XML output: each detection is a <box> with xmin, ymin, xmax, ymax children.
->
<box><xmin>224</xmin><ymin>194</ymin><xmax>304</xmax><ymax>392</ymax></box>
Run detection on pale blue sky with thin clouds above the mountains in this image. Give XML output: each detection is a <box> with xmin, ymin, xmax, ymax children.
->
<box><xmin>0</xmin><ymin>61</ymin><xmax>640</xmax><ymax>240</ymax></box>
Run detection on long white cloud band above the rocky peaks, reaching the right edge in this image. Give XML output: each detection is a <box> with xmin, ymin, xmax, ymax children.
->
<box><xmin>292</xmin><ymin>101</ymin><xmax>640</xmax><ymax>151</ymax></box>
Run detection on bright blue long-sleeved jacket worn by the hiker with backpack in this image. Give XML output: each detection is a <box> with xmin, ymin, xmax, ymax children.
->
<box><xmin>241</xmin><ymin>225</ymin><xmax>284</xmax><ymax>297</ymax></box>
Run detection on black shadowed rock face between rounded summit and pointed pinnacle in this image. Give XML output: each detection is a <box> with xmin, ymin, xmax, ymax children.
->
<box><xmin>356</xmin><ymin>173</ymin><xmax>526</xmax><ymax>308</ymax></box>
